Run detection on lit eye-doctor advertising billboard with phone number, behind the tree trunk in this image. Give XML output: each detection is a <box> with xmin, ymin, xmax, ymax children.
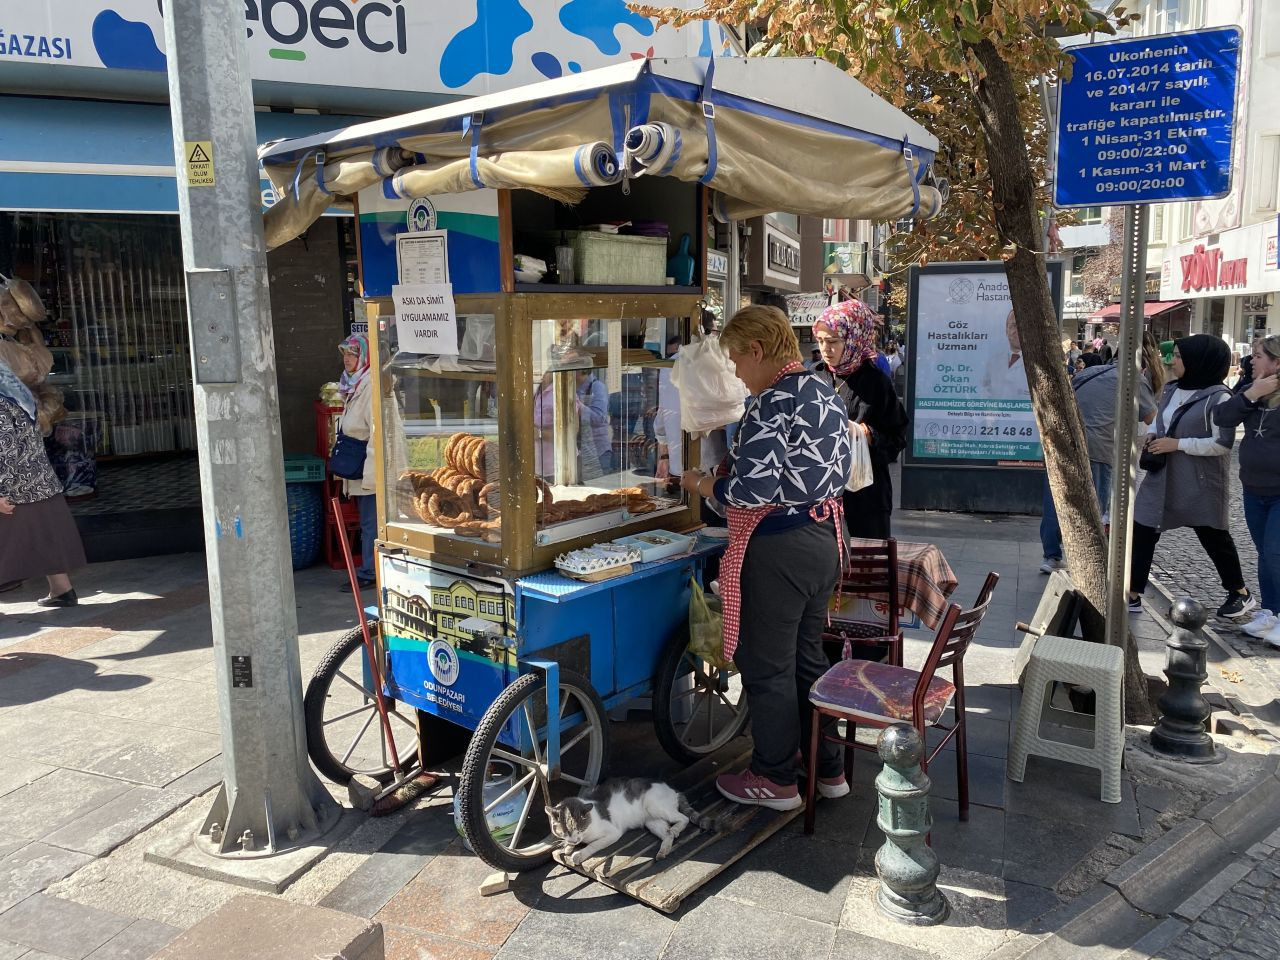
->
<box><xmin>908</xmin><ymin>262</ymin><xmax>1061</xmax><ymax>466</ymax></box>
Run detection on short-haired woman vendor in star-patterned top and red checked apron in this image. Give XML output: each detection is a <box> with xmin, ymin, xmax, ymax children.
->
<box><xmin>681</xmin><ymin>306</ymin><xmax>850</xmax><ymax>810</ymax></box>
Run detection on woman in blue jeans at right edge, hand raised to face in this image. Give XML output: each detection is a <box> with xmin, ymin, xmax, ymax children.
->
<box><xmin>1213</xmin><ymin>337</ymin><xmax>1280</xmax><ymax>646</ymax></box>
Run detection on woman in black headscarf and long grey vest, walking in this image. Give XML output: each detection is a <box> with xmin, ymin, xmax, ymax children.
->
<box><xmin>1129</xmin><ymin>333</ymin><xmax>1257</xmax><ymax>620</ymax></box>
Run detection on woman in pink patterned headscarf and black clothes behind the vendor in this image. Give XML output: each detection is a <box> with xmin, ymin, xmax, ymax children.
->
<box><xmin>813</xmin><ymin>300</ymin><xmax>910</xmax><ymax>540</ymax></box>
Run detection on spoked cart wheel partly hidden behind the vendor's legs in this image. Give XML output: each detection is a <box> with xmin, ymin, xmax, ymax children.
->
<box><xmin>653</xmin><ymin>630</ymin><xmax>746</xmax><ymax>764</ymax></box>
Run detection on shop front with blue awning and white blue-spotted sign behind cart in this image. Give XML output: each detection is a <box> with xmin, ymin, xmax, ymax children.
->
<box><xmin>0</xmin><ymin>0</ymin><xmax>726</xmax><ymax>559</ymax></box>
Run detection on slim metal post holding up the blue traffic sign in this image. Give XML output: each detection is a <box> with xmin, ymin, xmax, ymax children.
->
<box><xmin>1107</xmin><ymin>204</ymin><xmax>1147</xmax><ymax>646</ymax></box>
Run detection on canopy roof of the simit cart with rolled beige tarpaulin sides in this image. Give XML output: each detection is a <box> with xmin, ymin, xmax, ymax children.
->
<box><xmin>259</xmin><ymin>58</ymin><xmax>942</xmax><ymax>247</ymax></box>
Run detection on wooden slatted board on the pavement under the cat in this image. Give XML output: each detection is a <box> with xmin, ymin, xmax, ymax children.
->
<box><xmin>553</xmin><ymin>750</ymin><xmax>804</xmax><ymax>914</ymax></box>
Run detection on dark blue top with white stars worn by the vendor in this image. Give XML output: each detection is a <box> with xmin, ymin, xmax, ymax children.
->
<box><xmin>716</xmin><ymin>371</ymin><xmax>852</xmax><ymax>531</ymax></box>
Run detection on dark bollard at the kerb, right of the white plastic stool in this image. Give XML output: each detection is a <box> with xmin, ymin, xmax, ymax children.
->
<box><xmin>1151</xmin><ymin>599</ymin><xmax>1213</xmax><ymax>760</ymax></box>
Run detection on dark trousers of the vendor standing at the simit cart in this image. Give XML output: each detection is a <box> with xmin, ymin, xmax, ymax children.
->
<box><xmin>733</xmin><ymin>522</ymin><xmax>844</xmax><ymax>783</ymax></box>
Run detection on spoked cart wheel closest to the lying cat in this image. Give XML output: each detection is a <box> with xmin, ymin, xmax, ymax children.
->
<box><xmin>458</xmin><ymin>671</ymin><xmax>609</xmax><ymax>873</ymax></box>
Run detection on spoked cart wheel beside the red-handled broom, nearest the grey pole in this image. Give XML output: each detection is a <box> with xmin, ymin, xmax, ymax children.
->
<box><xmin>302</xmin><ymin>625</ymin><xmax>417</xmax><ymax>786</ymax></box>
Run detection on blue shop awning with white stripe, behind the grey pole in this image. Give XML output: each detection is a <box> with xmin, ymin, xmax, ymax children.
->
<box><xmin>0</xmin><ymin>96</ymin><xmax>371</xmax><ymax>214</ymax></box>
